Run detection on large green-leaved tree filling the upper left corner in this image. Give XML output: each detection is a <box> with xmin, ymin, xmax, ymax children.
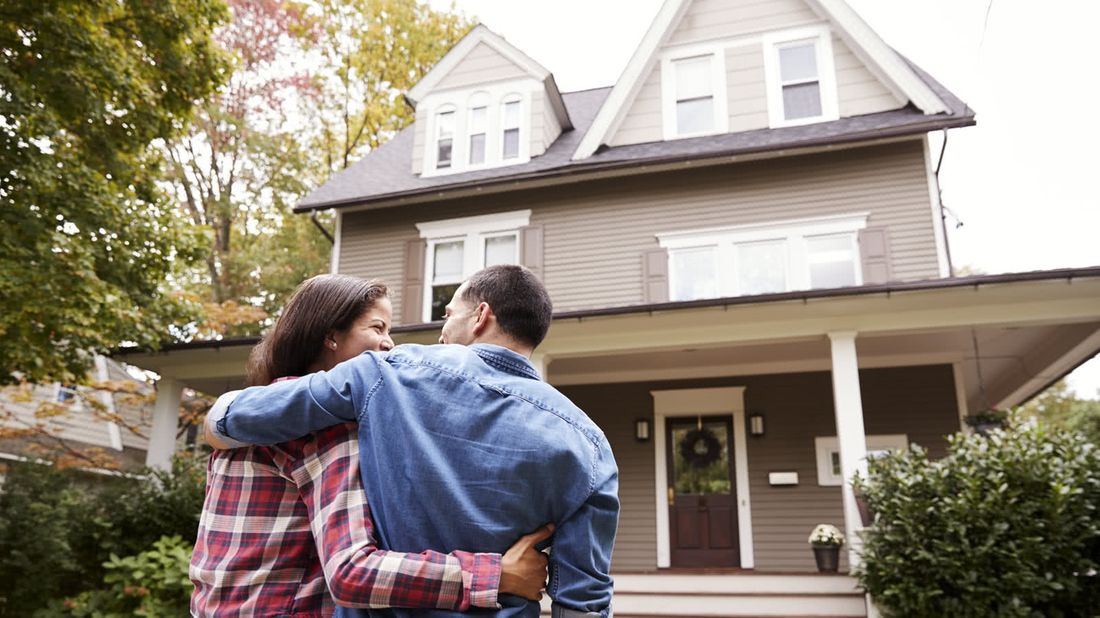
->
<box><xmin>0</xmin><ymin>0</ymin><xmax>226</xmax><ymax>384</ymax></box>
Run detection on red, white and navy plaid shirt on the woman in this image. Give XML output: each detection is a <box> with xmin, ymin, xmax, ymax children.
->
<box><xmin>190</xmin><ymin>417</ymin><xmax>501</xmax><ymax>617</ymax></box>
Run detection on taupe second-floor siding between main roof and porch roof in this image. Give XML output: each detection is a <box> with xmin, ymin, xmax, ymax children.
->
<box><xmin>340</xmin><ymin>140</ymin><xmax>938</xmax><ymax>323</ymax></box>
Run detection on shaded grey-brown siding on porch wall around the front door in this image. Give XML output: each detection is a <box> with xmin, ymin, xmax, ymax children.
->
<box><xmin>551</xmin><ymin>365</ymin><xmax>958</xmax><ymax>572</ymax></box>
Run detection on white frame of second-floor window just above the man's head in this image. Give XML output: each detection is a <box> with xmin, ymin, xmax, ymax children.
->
<box><xmin>416</xmin><ymin>210</ymin><xmax>531</xmax><ymax>322</ymax></box>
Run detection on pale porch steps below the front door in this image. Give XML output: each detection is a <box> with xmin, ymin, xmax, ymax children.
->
<box><xmin>542</xmin><ymin>573</ymin><xmax>867</xmax><ymax>618</ymax></box>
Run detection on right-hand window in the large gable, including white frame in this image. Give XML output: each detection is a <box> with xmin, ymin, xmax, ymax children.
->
<box><xmin>765</xmin><ymin>27</ymin><xmax>838</xmax><ymax>126</ymax></box>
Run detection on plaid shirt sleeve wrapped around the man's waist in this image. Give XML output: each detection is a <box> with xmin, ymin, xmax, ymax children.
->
<box><xmin>290</xmin><ymin>428</ymin><xmax>501</xmax><ymax>611</ymax></box>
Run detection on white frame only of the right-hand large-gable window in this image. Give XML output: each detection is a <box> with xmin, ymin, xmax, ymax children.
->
<box><xmin>763</xmin><ymin>25</ymin><xmax>840</xmax><ymax>129</ymax></box>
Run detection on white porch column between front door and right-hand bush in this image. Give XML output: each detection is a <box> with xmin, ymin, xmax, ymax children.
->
<box><xmin>828</xmin><ymin>331</ymin><xmax>867</xmax><ymax>567</ymax></box>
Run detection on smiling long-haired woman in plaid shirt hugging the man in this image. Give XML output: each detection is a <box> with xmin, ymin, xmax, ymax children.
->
<box><xmin>190</xmin><ymin>275</ymin><xmax>552</xmax><ymax>617</ymax></box>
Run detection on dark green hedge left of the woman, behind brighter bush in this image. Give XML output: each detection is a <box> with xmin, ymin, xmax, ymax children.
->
<box><xmin>0</xmin><ymin>450</ymin><xmax>205</xmax><ymax>618</ymax></box>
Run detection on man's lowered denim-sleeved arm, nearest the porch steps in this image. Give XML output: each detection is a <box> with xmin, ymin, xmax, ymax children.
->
<box><xmin>547</xmin><ymin>442</ymin><xmax>619</xmax><ymax>618</ymax></box>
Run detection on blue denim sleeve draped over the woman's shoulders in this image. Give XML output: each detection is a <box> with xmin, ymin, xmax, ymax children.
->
<box><xmin>211</xmin><ymin>352</ymin><xmax>383</xmax><ymax>446</ymax></box>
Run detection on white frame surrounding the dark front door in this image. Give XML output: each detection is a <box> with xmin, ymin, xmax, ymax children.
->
<box><xmin>649</xmin><ymin>386</ymin><xmax>755</xmax><ymax>569</ymax></box>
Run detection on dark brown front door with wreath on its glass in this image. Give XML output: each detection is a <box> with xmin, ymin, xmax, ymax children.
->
<box><xmin>667</xmin><ymin>417</ymin><xmax>740</xmax><ymax>567</ymax></box>
